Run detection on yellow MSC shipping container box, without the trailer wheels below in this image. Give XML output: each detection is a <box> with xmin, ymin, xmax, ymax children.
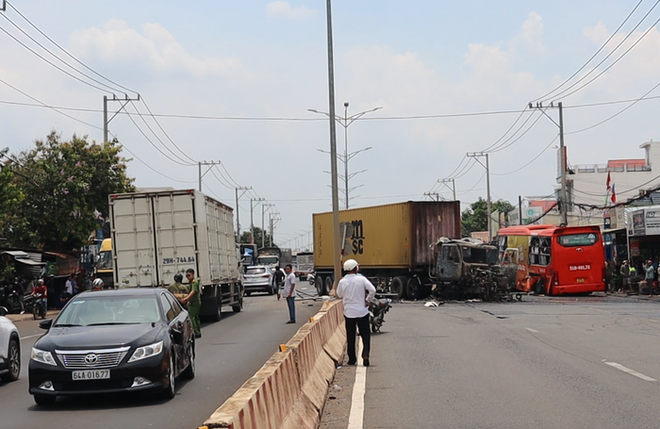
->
<box><xmin>313</xmin><ymin>201</ymin><xmax>461</xmax><ymax>270</ymax></box>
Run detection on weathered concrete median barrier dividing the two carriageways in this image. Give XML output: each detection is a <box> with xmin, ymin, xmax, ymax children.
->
<box><xmin>202</xmin><ymin>301</ymin><xmax>346</xmax><ymax>429</ymax></box>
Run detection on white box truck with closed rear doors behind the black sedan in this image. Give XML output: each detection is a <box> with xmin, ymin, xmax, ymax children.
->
<box><xmin>108</xmin><ymin>189</ymin><xmax>243</xmax><ymax>321</ymax></box>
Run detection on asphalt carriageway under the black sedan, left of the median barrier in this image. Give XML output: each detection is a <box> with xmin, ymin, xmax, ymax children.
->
<box><xmin>0</xmin><ymin>283</ymin><xmax>321</xmax><ymax>429</ymax></box>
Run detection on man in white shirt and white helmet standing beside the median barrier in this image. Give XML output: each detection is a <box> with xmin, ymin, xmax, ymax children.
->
<box><xmin>335</xmin><ymin>259</ymin><xmax>376</xmax><ymax>366</ymax></box>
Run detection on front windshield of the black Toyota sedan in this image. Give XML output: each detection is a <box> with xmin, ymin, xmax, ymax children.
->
<box><xmin>53</xmin><ymin>295</ymin><xmax>160</xmax><ymax>327</ymax></box>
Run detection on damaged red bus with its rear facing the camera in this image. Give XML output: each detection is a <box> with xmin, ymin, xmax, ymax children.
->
<box><xmin>497</xmin><ymin>225</ymin><xmax>605</xmax><ymax>295</ymax></box>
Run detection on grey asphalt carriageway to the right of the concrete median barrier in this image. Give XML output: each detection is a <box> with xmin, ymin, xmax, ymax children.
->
<box><xmin>322</xmin><ymin>295</ymin><xmax>660</xmax><ymax>429</ymax></box>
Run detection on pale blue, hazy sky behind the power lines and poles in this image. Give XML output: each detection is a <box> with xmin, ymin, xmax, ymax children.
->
<box><xmin>0</xmin><ymin>0</ymin><xmax>660</xmax><ymax>245</ymax></box>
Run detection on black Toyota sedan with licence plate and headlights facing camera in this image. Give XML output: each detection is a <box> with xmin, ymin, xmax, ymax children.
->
<box><xmin>28</xmin><ymin>288</ymin><xmax>195</xmax><ymax>405</ymax></box>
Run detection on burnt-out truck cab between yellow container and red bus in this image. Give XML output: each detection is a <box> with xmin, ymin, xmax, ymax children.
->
<box><xmin>432</xmin><ymin>237</ymin><xmax>509</xmax><ymax>301</ymax></box>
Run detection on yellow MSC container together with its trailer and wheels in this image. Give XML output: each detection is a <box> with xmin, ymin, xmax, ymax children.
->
<box><xmin>312</xmin><ymin>201</ymin><xmax>461</xmax><ymax>299</ymax></box>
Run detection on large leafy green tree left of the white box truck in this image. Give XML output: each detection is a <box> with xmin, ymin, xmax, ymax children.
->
<box><xmin>6</xmin><ymin>132</ymin><xmax>134</xmax><ymax>250</ymax></box>
